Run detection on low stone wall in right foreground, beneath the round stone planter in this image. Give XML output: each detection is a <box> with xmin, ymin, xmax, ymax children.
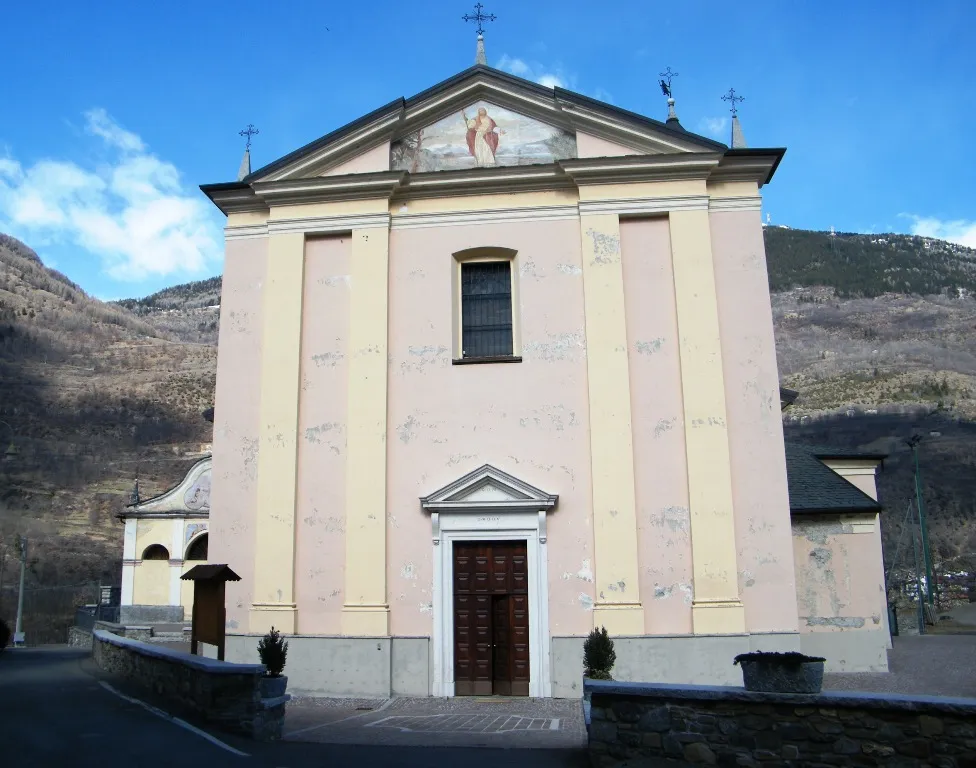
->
<box><xmin>584</xmin><ymin>680</ymin><xmax>976</xmax><ymax>768</ymax></box>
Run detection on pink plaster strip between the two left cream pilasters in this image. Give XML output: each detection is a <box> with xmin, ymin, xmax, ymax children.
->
<box><xmin>295</xmin><ymin>236</ymin><xmax>352</xmax><ymax>634</ymax></box>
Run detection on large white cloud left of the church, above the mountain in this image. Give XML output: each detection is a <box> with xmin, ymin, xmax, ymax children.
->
<box><xmin>0</xmin><ymin>109</ymin><xmax>220</xmax><ymax>281</ymax></box>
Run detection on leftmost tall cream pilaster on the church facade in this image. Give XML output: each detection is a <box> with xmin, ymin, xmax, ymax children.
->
<box><xmin>249</xmin><ymin>232</ymin><xmax>305</xmax><ymax>633</ymax></box>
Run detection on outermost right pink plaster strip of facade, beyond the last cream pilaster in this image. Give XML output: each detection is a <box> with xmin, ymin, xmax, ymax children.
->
<box><xmin>709</xmin><ymin>211</ymin><xmax>797</xmax><ymax>632</ymax></box>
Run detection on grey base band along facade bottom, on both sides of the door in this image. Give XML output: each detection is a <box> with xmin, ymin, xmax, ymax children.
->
<box><xmin>225</xmin><ymin>633</ymin><xmax>816</xmax><ymax>699</ymax></box>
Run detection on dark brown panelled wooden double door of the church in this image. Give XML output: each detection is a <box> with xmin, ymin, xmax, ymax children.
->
<box><xmin>454</xmin><ymin>541</ymin><xmax>529</xmax><ymax>696</ymax></box>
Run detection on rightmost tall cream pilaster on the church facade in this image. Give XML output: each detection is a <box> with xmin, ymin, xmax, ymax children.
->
<box><xmin>669</xmin><ymin>206</ymin><xmax>745</xmax><ymax>634</ymax></box>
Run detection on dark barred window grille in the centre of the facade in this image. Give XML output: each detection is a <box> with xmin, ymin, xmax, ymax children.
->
<box><xmin>461</xmin><ymin>261</ymin><xmax>512</xmax><ymax>357</ymax></box>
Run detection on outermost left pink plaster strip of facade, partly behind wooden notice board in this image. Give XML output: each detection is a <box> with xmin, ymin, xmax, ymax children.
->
<box><xmin>209</xmin><ymin>239</ymin><xmax>268</xmax><ymax>630</ymax></box>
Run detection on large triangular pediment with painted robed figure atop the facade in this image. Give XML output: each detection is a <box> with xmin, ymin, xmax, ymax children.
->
<box><xmin>244</xmin><ymin>65</ymin><xmax>727</xmax><ymax>184</ymax></box>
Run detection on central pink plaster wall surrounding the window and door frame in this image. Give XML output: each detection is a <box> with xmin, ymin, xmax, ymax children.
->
<box><xmin>387</xmin><ymin>220</ymin><xmax>593</xmax><ymax>635</ymax></box>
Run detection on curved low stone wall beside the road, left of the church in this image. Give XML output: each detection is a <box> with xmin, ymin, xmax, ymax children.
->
<box><xmin>92</xmin><ymin>630</ymin><xmax>288</xmax><ymax>741</ymax></box>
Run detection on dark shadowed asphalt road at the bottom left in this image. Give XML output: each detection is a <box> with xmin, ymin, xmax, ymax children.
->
<box><xmin>0</xmin><ymin>648</ymin><xmax>588</xmax><ymax>768</ymax></box>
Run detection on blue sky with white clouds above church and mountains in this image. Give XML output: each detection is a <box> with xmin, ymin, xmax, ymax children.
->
<box><xmin>0</xmin><ymin>0</ymin><xmax>976</xmax><ymax>298</ymax></box>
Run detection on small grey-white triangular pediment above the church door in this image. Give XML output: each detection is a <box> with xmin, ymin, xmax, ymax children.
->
<box><xmin>420</xmin><ymin>464</ymin><xmax>559</xmax><ymax>511</ymax></box>
